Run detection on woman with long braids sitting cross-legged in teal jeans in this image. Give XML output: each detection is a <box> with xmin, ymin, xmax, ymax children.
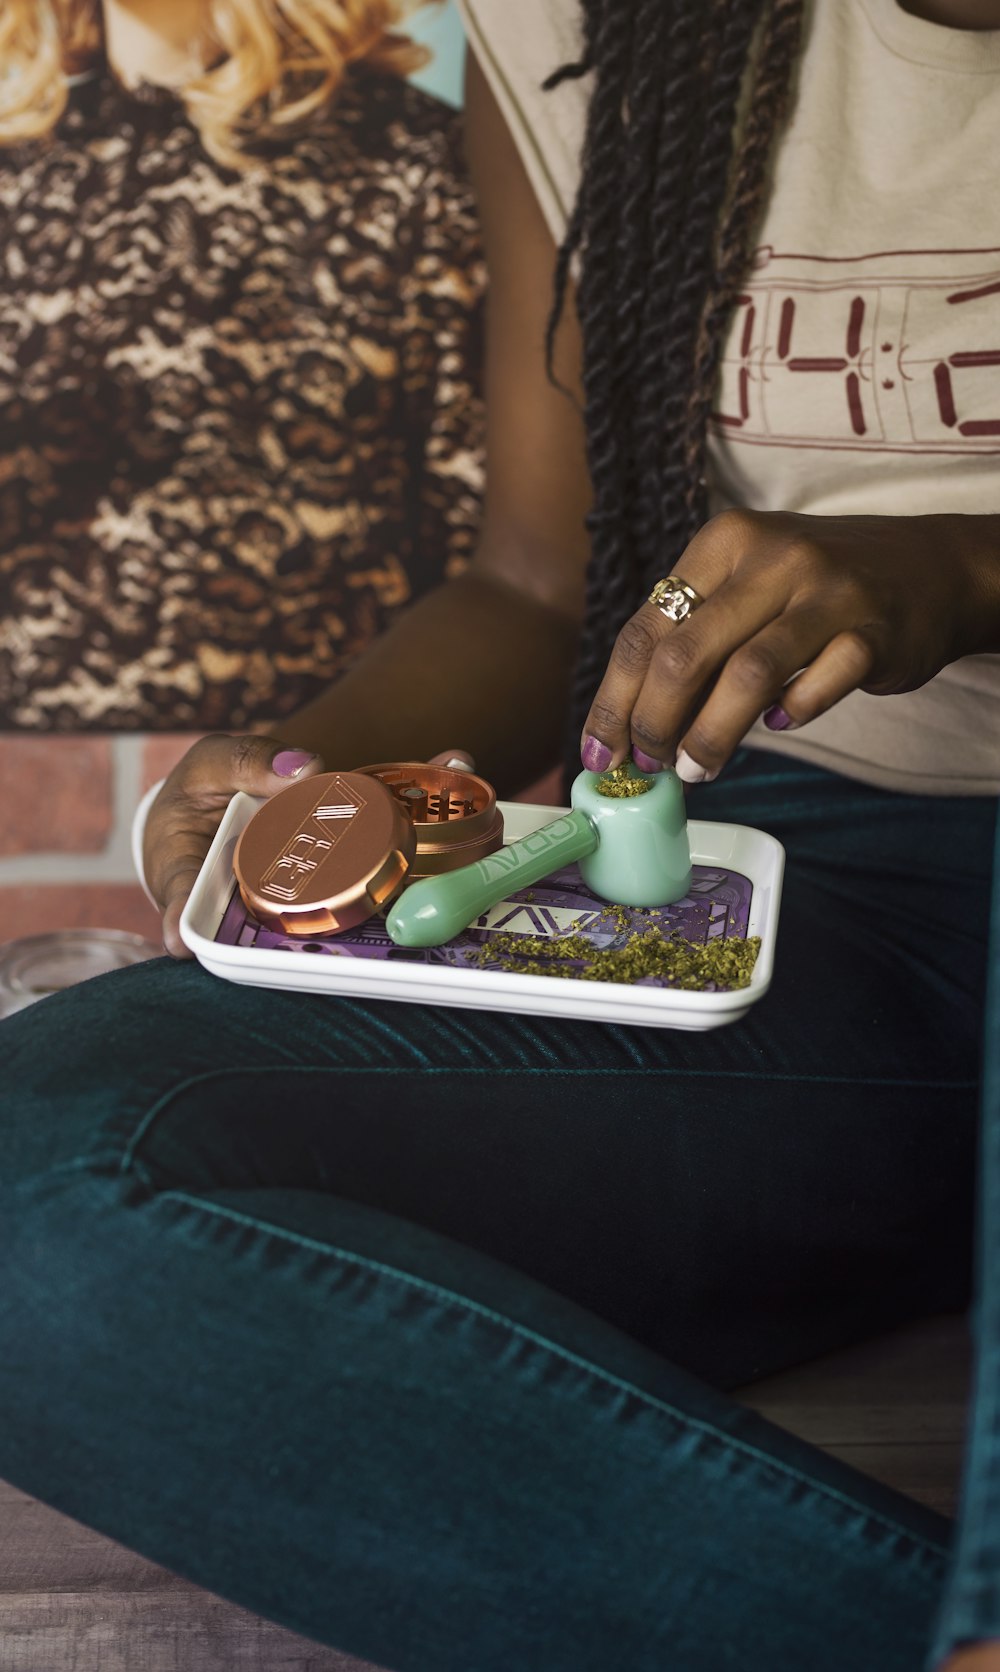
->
<box><xmin>0</xmin><ymin>0</ymin><xmax>1000</xmax><ymax>1672</ymax></box>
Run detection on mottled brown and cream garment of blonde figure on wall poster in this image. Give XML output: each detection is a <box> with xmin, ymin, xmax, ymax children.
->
<box><xmin>0</xmin><ymin>69</ymin><xmax>485</xmax><ymax>731</ymax></box>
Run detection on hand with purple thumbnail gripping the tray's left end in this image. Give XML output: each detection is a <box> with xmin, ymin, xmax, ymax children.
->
<box><xmin>142</xmin><ymin>734</ymin><xmax>323</xmax><ymax>958</ymax></box>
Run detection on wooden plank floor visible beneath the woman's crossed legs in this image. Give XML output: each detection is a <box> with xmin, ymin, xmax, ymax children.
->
<box><xmin>0</xmin><ymin>1319</ymin><xmax>968</xmax><ymax>1672</ymax></box>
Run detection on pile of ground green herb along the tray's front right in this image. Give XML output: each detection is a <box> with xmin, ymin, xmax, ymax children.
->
<box><xmin>478</xmin><ymin>929</ymin><xmax>761</xmax><ymax>993</ymax></box>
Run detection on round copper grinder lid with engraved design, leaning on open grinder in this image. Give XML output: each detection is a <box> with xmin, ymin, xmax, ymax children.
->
<box><xmin>232</xmin><ymin>772</ymin><xmax>416</xmax><ymax>935</ymax></box>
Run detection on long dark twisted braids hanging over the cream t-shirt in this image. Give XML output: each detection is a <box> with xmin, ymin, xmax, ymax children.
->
<box><xmin>545</xmin><ymin>0</ymin><xmax>804</xmax><ymax>759</ymax></box>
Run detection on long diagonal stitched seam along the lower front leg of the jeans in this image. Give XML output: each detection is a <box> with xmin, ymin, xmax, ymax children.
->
<box><xmin>122</xmin><ymin>1160</ymin><xmax>948</xmax><ymax>1560</ymax></box>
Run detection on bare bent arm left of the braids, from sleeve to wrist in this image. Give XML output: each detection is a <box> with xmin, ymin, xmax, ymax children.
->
<box><xmin>281</xmin><ymin>59</ymin><xmax>589</xmax><ymax>791</ymax></box>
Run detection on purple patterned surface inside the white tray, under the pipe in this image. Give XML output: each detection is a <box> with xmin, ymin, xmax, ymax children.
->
<box><xmin>216</xmin><ymin>864</ymin><xmax>753</xmax><ymax>986</ymax></box>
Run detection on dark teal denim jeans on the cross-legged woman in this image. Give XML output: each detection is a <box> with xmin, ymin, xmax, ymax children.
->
<box><xmin>0</xmin><ymin>752</ymin><xmax>1000</xmax><ymax>1672</ymax></box>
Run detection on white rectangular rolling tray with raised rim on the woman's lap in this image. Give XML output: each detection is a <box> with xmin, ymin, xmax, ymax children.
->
<box><xmin>181</xmin><ymin>793</ymin><xmax>784</xmax><ymax>1030</ymax></box>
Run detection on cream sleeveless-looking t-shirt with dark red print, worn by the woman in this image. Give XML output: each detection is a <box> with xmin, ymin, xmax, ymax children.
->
<box><xmin>460</xmin><ymin>0</ymin><xmax>1000</xmax><ymax>794</ymax></box>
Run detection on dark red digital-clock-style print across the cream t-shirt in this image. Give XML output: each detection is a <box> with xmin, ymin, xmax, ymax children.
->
<box><xmin>712</xmin><ymin>246</ymin><xmax>1000</xmax><ymax>453</ymax></box>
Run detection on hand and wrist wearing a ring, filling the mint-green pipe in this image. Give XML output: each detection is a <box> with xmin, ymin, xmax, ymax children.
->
<box><xmin>582</xmin><ymin>512</ymin><xmax>1000</xmax><ymax>782</ymax></box>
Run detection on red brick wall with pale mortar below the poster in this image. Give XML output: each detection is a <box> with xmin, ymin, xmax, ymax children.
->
<box><xmin>0</xmin><ymin>732</ymin><xmax>559</xmax><ymax>945</ymax></box>
